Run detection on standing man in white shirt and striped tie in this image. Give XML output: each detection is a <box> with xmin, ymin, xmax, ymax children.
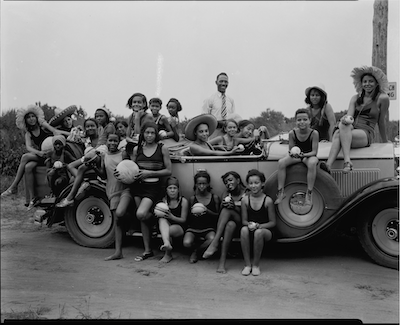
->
<box><xmin>202</xmin><ymin>72</ymin><xmax>236</xmax><ymax>124</ymax></box>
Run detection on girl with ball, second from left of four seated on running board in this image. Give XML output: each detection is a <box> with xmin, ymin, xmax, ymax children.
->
<box><xmin>183</xmin><ymin>171</ymin><xmax>221</xmax><ymax>263</ymax></box>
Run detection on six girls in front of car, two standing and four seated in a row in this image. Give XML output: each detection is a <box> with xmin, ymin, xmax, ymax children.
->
<box><xmin>103</xmin><ymin>122</ymin><xmax>276</xmax><ymax>276</ymax></box>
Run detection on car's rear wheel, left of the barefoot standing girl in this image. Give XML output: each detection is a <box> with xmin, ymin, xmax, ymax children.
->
<box><xmin>65</xmin><ymin>189</ymin><xmax>115</xmax><ymax>248</ymax></box>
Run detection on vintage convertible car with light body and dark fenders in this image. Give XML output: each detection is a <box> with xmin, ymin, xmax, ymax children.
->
<box><xmin>29</xmin><ymin>138</ymin><xmax>399</xmax><ymax>268</ymax></box>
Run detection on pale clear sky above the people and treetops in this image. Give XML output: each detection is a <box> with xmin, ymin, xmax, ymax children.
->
<box><xmin>1</xmin><ymin>0</ymin><xmax>400</xmax><ymax>120</ymax></box>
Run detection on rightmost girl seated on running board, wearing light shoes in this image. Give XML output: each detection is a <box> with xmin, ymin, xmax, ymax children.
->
<box><xmin>240</xmin><ymin>169</ymin><xmax>276</xmax><ymax>276</ymax></box>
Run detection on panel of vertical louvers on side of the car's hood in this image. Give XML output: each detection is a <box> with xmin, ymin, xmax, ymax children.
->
<box><xmin>331</xmin><ymin>168</ymin><xmax>380</xmax><ymax>198</ymax></box>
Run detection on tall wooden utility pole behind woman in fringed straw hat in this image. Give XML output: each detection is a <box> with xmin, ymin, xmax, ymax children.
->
<box><xmin>372</xmin><ymin>0</ymin><xmax>389</xmax><ymax>142</ymax></box>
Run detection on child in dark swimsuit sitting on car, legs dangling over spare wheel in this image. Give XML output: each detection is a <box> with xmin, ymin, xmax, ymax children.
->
<box><xmin>275</xmin><ymin>108</ymin><xmax>319</xmax><ymax>206</ymax></box>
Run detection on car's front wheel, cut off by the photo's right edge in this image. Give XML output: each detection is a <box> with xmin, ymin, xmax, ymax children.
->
<box><xmin>357</xmin><ymin>202</ymin><xmax>399</xmax><ymax>269</ymax></box>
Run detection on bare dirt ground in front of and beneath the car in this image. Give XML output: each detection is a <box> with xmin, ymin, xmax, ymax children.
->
<box><xmin>1</xmin><ymin>196</ymin><xmax>399</xmax><ymax>323</ymax></box>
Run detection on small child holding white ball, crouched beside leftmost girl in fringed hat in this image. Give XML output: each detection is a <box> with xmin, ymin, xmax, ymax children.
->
<box><xmin>46</xmin><ymin>135</ymin><xmax>74</xmax><ymax>196</ymax></box>
